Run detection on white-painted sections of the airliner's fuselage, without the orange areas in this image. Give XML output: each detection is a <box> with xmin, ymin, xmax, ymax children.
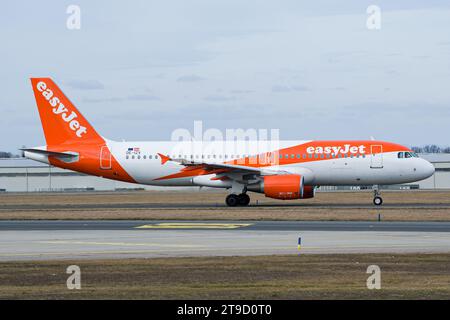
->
<box><xmin>107</xmin><ymin>141</ymin><xmax>434</xmax><ymax>187</ymax></box>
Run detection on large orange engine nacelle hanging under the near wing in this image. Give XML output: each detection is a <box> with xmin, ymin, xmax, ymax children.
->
<box><xmin>247</xmin><ymin>174</ymin><xmax>315</xmax><ymax>200</ymax></box>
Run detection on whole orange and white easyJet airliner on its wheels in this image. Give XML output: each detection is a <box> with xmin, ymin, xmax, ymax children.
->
<box><xmin>23</xmin><ymin>78</ymin><xmax>434</xmax><ymax>206</ymax></box>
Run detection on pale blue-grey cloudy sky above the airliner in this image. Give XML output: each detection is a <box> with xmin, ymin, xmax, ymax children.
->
<box><xmin>0</xmin><ymin>0</ymin><xmax>450</xmax><ymax>153</ymax></box>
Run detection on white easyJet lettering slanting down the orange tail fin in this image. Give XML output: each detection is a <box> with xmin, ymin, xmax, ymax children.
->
<box><xmin>36</xmin><ymin>81</ymin><xmax>87</xmax><ymax>138</ymax></box>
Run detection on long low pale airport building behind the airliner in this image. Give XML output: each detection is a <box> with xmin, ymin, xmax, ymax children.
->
<box><xmin>0</xmin><ymin>153</ymin><xmax>450</xmax><ymax>192</ymax></box>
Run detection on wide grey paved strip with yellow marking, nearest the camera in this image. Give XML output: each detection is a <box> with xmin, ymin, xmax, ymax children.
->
<box><xmin>0</xmin><ymin>220</ymin><xmax>450</xmax><ymax>261</ymax></box>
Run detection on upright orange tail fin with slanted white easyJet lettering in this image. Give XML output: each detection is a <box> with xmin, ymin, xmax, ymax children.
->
<box><xmin>31</xmin><ymin>78</ymin><xmax>103</xmax><ymax>146</ymax></box>
